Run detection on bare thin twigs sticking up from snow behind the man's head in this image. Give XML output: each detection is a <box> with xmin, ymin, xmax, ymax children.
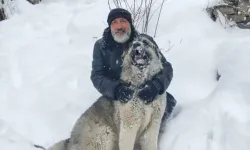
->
<box><xmin>108</xmin><ymin>0</ymin><xmax>166</xmax><ymax>37</ymax></box>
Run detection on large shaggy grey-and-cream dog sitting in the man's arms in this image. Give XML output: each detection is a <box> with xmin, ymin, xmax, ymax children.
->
<box><xmin>49</xmin><ymin>34</ymin><xmax>166</xmax><ymax>150</ymax></box>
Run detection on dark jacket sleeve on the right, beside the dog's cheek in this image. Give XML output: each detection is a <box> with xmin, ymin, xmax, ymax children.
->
<box><xmin>153</xmin><ymin>52</ymin><xmax>173</xmax><ymax>94</ymax></box>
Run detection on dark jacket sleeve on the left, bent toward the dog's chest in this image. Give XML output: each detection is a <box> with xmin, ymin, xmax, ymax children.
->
<box><xmin>90</xmin><ymin>40</ymin><xmax>120</xmax><ymax>99</ymax></box>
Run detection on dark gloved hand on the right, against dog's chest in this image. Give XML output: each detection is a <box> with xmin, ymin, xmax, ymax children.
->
<box><xmin>138</xmin><ymin>80</ymin><xmax>161</xmax><ymax>104</ymax></box>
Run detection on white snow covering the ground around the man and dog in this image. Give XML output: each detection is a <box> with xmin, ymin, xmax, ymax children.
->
<box><xmin>0</xmin><ymin>0</ymin><xmax>250</xmax><ymax>150</ymax></box>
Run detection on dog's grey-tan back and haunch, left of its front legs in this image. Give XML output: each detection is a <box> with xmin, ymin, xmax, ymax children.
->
<box><xmin>49</xmin><ymin>96</ymin><xmax>117</xmax><ymax>150</ymax></box>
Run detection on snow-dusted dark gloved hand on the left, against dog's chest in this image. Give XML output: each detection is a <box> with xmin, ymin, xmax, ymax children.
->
<box><xmin>115</xmin><ymin>83</ymin><xmax>134</xmax><ymax>103</ymax></box>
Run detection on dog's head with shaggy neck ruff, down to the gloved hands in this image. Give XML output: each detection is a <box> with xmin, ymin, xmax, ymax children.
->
<box><xmin>121</xmin><ymin>34</ymin><xmax>163</xmax><ymax>86</ymax></box>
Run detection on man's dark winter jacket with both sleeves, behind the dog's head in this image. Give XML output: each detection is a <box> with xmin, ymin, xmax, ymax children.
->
<box><xmin>91</xmin><ymin>26</ymin><xmax>173</xmax><ymax>99</ymax></box>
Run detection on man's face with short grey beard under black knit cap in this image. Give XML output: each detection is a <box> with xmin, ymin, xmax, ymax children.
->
<box><xmin>110</xmin><ymin>18</ymin><xmax>131</xmax><ymax>43</ymax></box>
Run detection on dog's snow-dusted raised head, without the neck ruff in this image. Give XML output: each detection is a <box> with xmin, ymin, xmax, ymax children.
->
<box><xmin>124</xmin><ymin>35</ymin><xmax>159</xmax><ymax>68</ymax></box>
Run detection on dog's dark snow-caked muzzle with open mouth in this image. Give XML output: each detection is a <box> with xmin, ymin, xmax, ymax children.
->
<box><xmin>131</xmin><ymin>46</ymin><xmax>150</xmax><ymax>66</ymax></box>
